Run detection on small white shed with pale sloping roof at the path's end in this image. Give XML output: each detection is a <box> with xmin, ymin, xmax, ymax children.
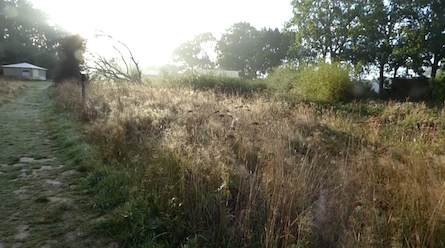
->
<box><xmin>2</xmin><ymin>63</ymin><xmax>47</xmax><ymax>80</ymax></box>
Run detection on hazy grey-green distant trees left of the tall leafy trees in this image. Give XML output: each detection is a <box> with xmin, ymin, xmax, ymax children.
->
<box><xmin>172</xmin><ymin>22</ymin><xmax>293</xmax><ymax>79</ymax></box>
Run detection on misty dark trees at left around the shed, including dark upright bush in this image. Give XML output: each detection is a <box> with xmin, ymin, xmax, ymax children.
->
<box><xmin>0</xmin><ymin>0</ymin><xmax>86</xmax><ymax>81</ymax></box>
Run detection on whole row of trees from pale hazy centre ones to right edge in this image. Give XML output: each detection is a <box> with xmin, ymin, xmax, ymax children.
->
<box><xmin>173</xmin><ymin>0</ymin><xmax>445</xmax><ymax>90</ymax></box>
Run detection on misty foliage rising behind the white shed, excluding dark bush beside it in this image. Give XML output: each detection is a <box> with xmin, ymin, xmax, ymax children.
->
<box><xmin>0</xmin><ymin>0</ymin><xmax>63</xmax><ymax>78</ymax></box>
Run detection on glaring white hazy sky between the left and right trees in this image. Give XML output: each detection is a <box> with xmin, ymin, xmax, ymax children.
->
<box><xmin>29</xmin><ymin>0</ymin><xmax>292</xmax><ymax>66</ymax></box>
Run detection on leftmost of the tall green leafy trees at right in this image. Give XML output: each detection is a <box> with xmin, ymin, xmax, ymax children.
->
<box><xmin>287</xmin><ymin>0</ymin><xmax>359</xmax><ymax>61</ymax></box>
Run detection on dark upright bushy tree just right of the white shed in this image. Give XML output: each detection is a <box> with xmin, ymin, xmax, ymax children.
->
<box><xmin>55</xmin><ymin>35</ymin><xmax>86</xmax><ymax>83</ymax></box>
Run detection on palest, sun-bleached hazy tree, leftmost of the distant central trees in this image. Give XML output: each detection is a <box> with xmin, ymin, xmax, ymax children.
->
<box><xmin>173</xmin><ymin>33</ymin><xmax>216</xmax><ymax>70</ymax></box>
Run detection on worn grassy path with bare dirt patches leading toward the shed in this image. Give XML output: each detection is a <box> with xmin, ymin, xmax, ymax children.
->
<box><xmin>0</xmin><ymin>82</ymin><xmax>116</xmax><ymax>248</ymax></box>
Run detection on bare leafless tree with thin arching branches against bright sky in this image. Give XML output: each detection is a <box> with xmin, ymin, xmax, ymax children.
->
<box><xmin>86</xmin><ymin>31</ymin><xmax>142</xmax><ymax>84</ymax></box>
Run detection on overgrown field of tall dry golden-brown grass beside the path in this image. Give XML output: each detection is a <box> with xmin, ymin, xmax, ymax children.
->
<box><xmin>54</xmin><ymin>80</ymin><xmax>445</xmax><ymax>247</ymax></box>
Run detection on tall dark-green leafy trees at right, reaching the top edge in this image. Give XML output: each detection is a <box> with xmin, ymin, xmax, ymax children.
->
<box><xmin>287</xmin><ymin>0</ymin><xmax>445</xmax><ymax>83</ymax></box>
